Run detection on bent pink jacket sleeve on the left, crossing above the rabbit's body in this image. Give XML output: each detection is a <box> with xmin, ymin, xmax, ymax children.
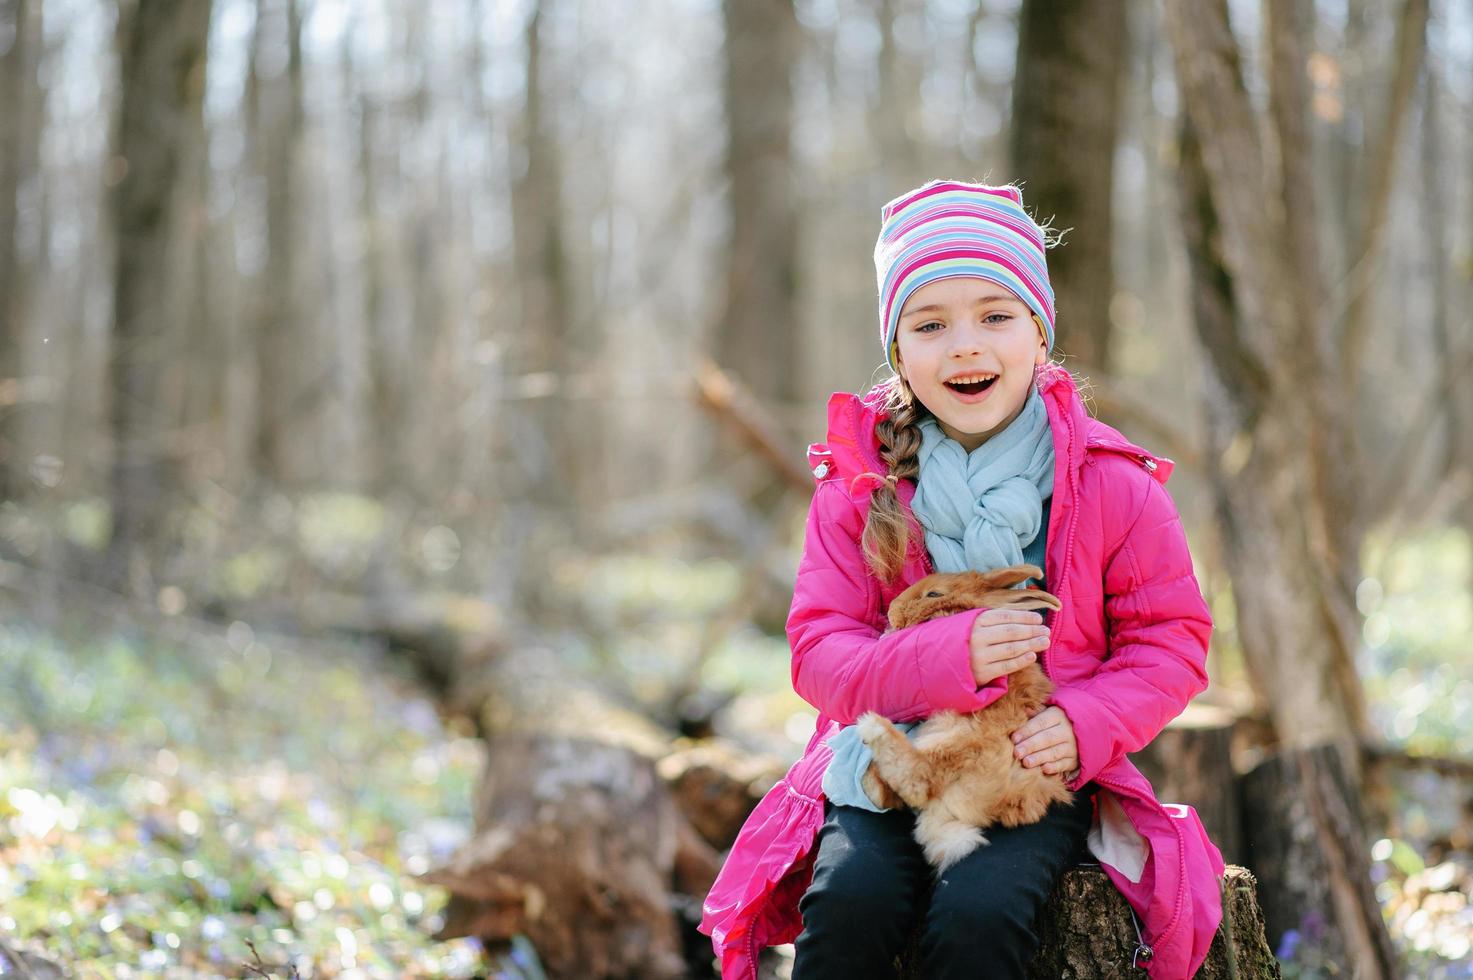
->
<box><xmin>787</xmin><ymin>479</ymin><xmax>1008</xmax><ymax>725</ymax></box>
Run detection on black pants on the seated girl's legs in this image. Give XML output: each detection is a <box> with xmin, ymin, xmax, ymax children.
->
<box><xmin>792</xmin><ymin>783</ymin><xmax>1096</xmax><ymax>980</ymax></box>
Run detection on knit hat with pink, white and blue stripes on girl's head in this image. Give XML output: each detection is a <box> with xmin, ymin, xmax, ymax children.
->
<box><xmin>875</xmin><ymin>180</ymin><xmax>1053</xmax><ymax>373</ymax></box>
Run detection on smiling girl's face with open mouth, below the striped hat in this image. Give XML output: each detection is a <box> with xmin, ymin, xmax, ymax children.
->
<box><xmin>896</xmin><ymin>276</ymin><xmax>1049</xmax><ymax>452</ymax></box>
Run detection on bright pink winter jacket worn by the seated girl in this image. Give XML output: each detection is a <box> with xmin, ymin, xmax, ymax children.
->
<box><xmin>700</xmin><ymin>364</ymin><xmax>1223</xmax><ymax>980</ymax></box>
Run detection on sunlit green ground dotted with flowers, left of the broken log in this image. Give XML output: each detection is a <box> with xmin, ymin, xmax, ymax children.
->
<box><xmin>0</xmin><ymin>616</ymin><xmax>482</xmax><ymax>977</ymax></box>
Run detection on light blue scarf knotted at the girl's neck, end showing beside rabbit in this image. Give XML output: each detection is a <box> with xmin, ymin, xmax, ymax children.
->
<box><xmin>823</xmin><ymin>388</ymin><xmax>1053</xmax><ymax>813</ymax></box>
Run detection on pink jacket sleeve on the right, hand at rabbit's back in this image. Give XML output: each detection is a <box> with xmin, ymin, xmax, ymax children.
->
<box><xmin>1049</xmin><ymin>479</ymin><xmax>1212</xmax><ymax>790</ymax></box>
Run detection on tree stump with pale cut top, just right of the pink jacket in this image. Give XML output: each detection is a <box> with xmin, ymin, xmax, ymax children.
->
<box><xmin>1130</xmin><ymin>704</ymin><xmax>1245</xmax><ymax>864</ymax></box>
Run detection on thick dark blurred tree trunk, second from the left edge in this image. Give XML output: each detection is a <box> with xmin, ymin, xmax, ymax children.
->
<box><xmin>105</xmin><ymin>0</ymin><xmax>211</xmax><ymax>589</ymax></box>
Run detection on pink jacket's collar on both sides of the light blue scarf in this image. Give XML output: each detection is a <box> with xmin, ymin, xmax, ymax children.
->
<box><xmin>809</xmin><ymin>361</ymin><xmax>1175</xmax><ymax>497</ymax></box>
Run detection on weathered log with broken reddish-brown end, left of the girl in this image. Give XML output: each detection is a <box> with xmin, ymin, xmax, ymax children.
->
<box><xmin>420</xmin><ymin>735</ymin><xmax>689</xmax><ymax>980</ymax></box>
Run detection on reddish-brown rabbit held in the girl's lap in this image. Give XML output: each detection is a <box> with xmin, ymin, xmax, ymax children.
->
<box><xmin>857</xmin><ymin>564</ymin><xmax>1072</xmax><ymax>871</ymax></box>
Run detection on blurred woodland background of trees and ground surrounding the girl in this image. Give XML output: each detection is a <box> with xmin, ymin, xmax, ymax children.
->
<box><xmin>0</xmin><ymin>0</ymin><xmax>1473</xmax><ymax>977</ymax></box>
